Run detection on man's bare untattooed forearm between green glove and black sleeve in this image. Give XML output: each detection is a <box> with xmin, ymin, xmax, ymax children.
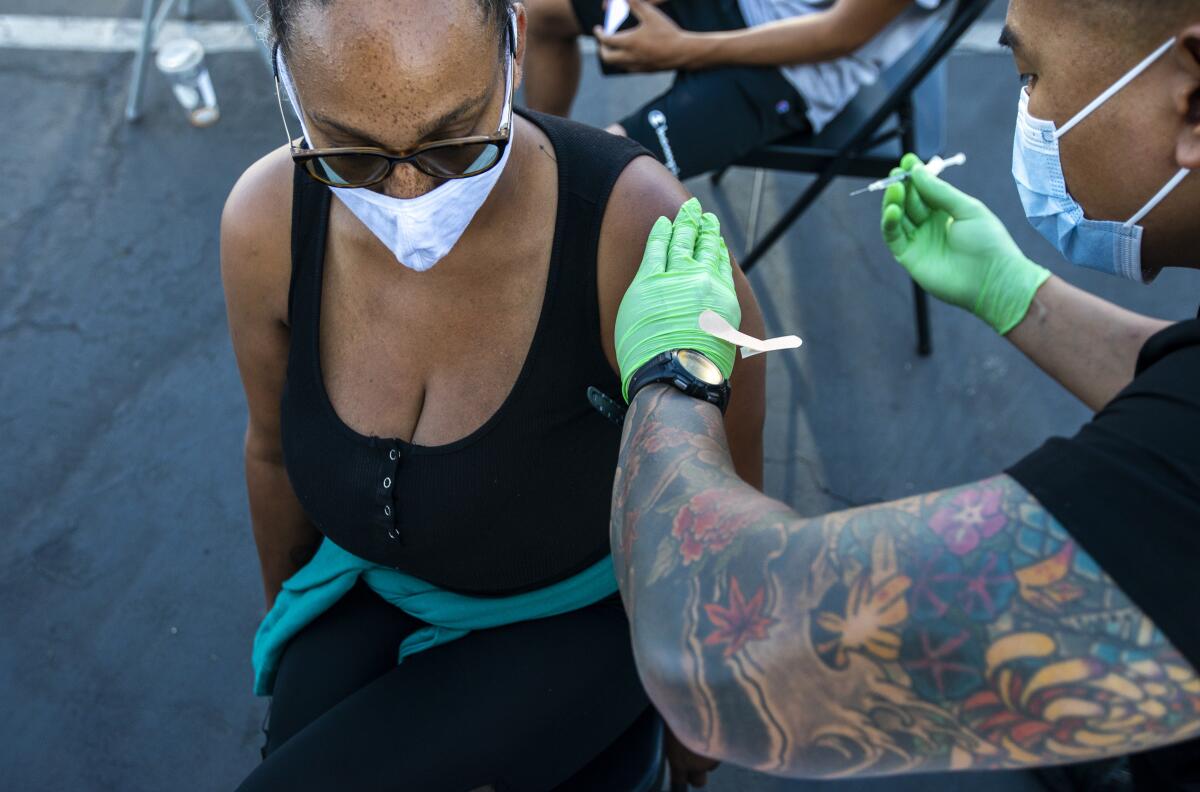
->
<box><xmin>1007</xmin><ymin>277</ymin><xmax>1170</xmax><ymax>410</ymax></box>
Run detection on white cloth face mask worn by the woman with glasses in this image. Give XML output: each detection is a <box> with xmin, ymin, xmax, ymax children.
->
<box><xmin>278</xmin><ymin>22</ymin><xmax>516</xmax><ymax>272</ymax></box>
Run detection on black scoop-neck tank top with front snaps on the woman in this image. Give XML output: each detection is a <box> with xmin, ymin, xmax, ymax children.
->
<box><xmin>281</xmin><ymin>112</ymin><xmax>646</xmax><ymax>595</ymax></box>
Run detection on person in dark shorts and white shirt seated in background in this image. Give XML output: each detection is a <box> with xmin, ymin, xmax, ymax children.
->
<box><xmin>526</xmin><ymin>0</ymin><xmax>942</xmax><ymax>179</ymax></box>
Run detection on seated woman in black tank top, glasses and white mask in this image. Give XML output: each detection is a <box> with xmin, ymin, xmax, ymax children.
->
<box><xmin>222</xmin><ymin>0</ymin><xmax>763</xmax><ymax>790</ymax></box>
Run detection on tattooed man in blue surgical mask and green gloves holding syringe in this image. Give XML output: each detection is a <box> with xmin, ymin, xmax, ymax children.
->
<box><xmin>612</xmin><ymin>0</ymin><xmax>1200</xmax><ymax>791</ymax></box>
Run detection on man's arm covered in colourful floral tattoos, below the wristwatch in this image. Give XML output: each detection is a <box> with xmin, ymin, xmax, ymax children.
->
<box><xmin>612</xmin><ymin>385</ymin><xmax>1200</xmax><ymax>776</ymax></box>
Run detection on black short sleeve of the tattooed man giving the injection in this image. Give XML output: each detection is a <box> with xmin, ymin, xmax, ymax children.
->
<box><xmin>1008</xmin><ymin>320</ymin><xmax>1200</xmax><ymax>668</ymax></box>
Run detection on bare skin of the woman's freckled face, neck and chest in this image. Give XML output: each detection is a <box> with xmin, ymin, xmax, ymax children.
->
<box><xmin>266</xmin><ymin>0</ymin><xmax>557</xmax><ymax>453</ymax></box>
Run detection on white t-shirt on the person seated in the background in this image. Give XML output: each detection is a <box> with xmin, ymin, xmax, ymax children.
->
<box><xmin>738</xmin><ymin>0</ymin><xmax>941</xmax><ymax>132</ymax></box>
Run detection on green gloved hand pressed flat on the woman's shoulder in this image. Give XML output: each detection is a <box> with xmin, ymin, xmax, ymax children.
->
<box><xmin>616</xmin><ymin>198</ymin><xmax>742</xmax><ymax>401</ymax></box>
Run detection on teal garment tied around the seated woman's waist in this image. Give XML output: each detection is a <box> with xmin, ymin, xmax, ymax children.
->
<box><xmin>252</xmin><ymin>539</ymin><xmax>617</xmax><ymax>696</ymax></box>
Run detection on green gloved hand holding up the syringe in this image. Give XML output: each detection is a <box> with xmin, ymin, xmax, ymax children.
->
<box><xmin>882</xmin><ymin>154</ymin><xmax>1050</xmax><ymax>335</ymax></box>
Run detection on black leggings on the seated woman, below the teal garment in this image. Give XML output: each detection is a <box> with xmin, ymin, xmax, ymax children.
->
<box><xmin>239</xmin><ymin>581</ymin><xmax>649</xmax><ymax>792</ymax></box>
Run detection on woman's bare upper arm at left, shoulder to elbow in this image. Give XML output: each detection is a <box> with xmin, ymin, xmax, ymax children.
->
<box><xmin>221</xmin><ymin>150</ymin><xmax>292</xmax><ymax>460</ymax></box>
